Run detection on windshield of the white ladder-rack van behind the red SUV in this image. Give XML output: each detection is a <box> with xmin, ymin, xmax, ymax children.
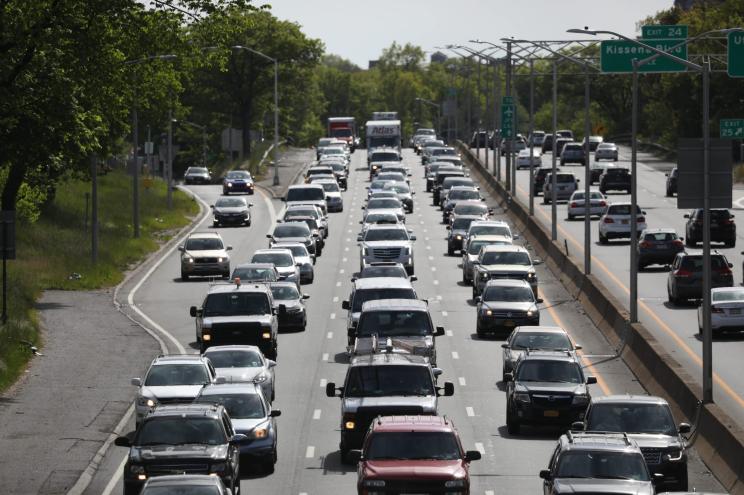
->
<box><xmin>344</xmin><ymin>365</ymin><xmax>434</xmax><ymax>397</ymax></box>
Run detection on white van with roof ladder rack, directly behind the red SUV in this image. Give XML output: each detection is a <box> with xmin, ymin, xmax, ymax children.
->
<box><xmin>326</xmin><ymin>350</ymin><xmax>455</xmax><ymax>462</ymax></box>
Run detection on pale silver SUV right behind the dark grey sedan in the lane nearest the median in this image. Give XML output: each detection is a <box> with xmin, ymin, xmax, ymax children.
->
<box><xmin>473</xmin><ymin>245</ymin><xmax>542</xmax><ymax>301</ymax></box>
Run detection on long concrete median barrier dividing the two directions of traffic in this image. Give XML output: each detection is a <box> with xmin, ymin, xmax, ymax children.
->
<box><xmin>458</xmin><ymin>143</ymin><xmax>744</xmax><ymax>495</ymax></box>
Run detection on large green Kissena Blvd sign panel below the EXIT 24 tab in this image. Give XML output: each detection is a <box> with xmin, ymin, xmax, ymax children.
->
<box><xmin>599</xmin><ymin>39</ymin><xmax>687</xmax><ymax>73</ymax></box>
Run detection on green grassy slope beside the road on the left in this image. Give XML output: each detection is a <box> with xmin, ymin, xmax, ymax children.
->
<box><xmin>0</xmin><ymin>170</ymin><xmax>199</xmax><ymax>390</ymax></box>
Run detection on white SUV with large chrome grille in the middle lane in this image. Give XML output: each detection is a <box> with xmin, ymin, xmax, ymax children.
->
<box><xmin>357</xmin><ymin>225</ymin><xmax>416</xmax><ymax>275</ymax></box>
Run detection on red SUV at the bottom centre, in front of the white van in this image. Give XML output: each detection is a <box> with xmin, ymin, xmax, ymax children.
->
<box><xmin>350</xmin><ymin>416</ymin><xmax>481</xmax><ymax>495</ymax></box>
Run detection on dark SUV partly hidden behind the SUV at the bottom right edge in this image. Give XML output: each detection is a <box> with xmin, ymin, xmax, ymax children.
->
<box><xmin>574</xmin><ymin>395</ymin><xmax>690</xmax><ymax>493</ymax></box>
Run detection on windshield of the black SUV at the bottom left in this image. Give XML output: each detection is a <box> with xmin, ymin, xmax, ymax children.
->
<box><xmin>134</xmin><ymin>416</ymin><xmax>227</xmax><ymax>447</ymax></box>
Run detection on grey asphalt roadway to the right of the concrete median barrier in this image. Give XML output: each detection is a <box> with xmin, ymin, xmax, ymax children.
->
<box><xmin>502</xmin><ymin>142</ymin><xmax>744</xmax><ymax>424</ymax></box>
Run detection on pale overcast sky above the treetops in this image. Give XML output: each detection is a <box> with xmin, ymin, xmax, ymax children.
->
<box><xmin>266</xmin><ymin>0</ymin><xmax>674</xmax><ymax>68</ymax></box>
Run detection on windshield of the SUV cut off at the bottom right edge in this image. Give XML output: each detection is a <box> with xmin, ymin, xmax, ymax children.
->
<box><xmin>555</xmin><ymin>450</ymin><xmax>649</xmax><ymax>481</ymax></box>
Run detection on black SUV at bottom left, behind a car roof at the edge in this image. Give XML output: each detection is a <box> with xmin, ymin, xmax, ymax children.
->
<box><xmin>114</xmin><ymin>404</ymin><xmax>248</xmax><ymax>495</ymax></box>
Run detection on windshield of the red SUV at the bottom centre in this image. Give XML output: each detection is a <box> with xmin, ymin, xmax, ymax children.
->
<box><xmin>364</xmin><ymin>431</ymin><xmax>462</xmax><ymax>461</ymax></box>
